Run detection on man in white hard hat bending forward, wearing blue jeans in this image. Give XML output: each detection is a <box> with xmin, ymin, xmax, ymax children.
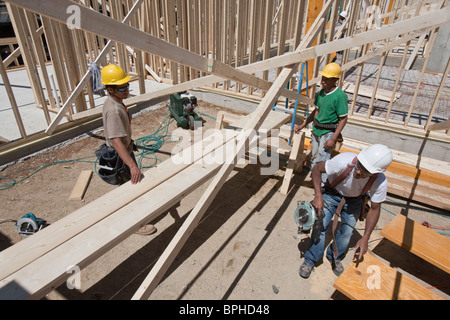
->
<box><xmin>299</xmin><ymin>144</ymin><xmax>392</xmax><ymax>278</ymax></box>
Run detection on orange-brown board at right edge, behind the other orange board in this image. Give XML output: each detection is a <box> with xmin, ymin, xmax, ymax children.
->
<box><xmin>380</xmin><ymin>214</ymin><xmax>450</xmax><ymax>273</ymax></box>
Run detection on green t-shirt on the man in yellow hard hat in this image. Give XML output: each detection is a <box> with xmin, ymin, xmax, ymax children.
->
<box><xmin>313</xmin><ymin>87</ymin><xmax>348</xmax><ymax>136</ymax></box>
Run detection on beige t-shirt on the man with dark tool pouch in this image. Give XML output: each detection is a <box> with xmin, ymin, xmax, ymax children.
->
<box><xmin>102</xmin><ymin>97</ymin><xmax>133</xmax><ymax>153</ymax></box>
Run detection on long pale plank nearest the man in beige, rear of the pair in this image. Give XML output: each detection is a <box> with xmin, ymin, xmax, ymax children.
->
<box><xmin>0</xmin><ymin>124</ymin><xmax>237</xmax><ymax>279</ymax></box>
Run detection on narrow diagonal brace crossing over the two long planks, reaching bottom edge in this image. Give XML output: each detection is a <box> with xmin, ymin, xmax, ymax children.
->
<box><xmin>133</xmin><ymin>0</ymin><xmax>333</xmax><ymax>299</ymax></box>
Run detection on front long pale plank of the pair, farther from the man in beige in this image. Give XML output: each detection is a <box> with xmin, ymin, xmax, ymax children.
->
<box><xmin>0</xmin><ymin>112</ymin><xmax>288</xmax><ymax>299</ymax></box>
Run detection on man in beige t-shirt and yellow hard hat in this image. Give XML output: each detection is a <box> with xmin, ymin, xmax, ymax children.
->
<box><xmin>101</xmin><ymin>64</ymin><xmax>156</xmax><ymax>235</ymax></box>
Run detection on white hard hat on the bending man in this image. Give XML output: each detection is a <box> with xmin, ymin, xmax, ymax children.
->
<box><xmin>358</xmin><ymin>144</ymin><xmax>392</xmax><ymax>173</ymax></box>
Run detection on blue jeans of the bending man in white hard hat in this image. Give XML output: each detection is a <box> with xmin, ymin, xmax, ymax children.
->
<box><xmin>305</xmin><ymin>192</ymin><xmax>362</xmax><ymax>266</ymax></box>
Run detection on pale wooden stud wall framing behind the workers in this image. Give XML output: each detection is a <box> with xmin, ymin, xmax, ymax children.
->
<box><xmin>0</xmin><ymin>0</ymin><xmax>448</xmax><ymax>151</ymax></box>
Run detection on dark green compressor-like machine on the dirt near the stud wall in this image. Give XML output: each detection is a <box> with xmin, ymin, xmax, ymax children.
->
<box><xmin>169</xmin><ymin>91</ymin><xmax>203</xmax><ymax>130</ymax></box>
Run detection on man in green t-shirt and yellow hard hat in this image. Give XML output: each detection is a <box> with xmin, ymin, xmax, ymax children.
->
<box><xmin>294</xmin><ymin>62</ymin><xmax>348</xmax><ymax>185</ymax></box>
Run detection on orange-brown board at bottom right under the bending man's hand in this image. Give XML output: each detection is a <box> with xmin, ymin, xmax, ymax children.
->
<box><xmin>333</xmin><ymin>254</ymin><xmax>444</xmax><ymax>300</ymax></box>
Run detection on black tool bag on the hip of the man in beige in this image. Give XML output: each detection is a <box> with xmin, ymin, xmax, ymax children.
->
<box><xmin>95</xmin><ymin>143</ymin><xmax>131</xmax><ymax>185</ymax></box>
